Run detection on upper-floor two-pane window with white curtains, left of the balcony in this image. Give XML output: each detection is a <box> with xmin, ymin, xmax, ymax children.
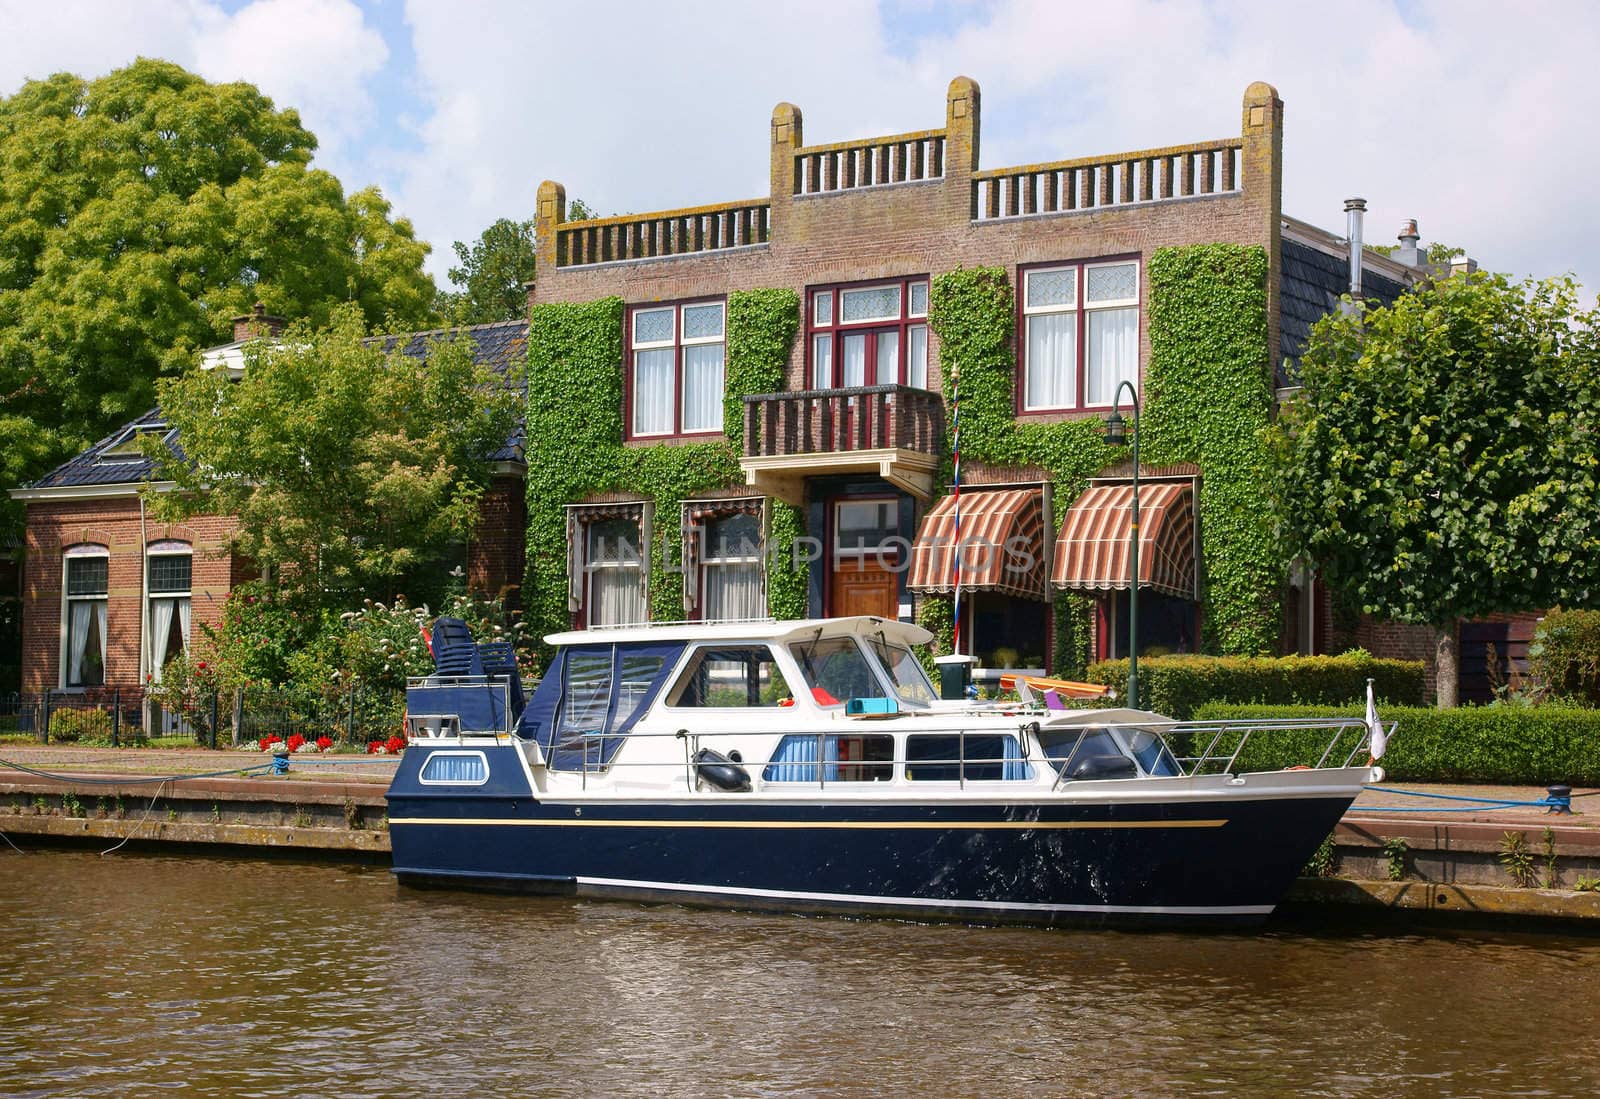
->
<box><xmin>627</xmin><ymin>301</ymin><xmax>726</xmax><ymax>438</ymax></box>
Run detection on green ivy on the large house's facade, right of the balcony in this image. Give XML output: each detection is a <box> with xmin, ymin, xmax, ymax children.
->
<box><xmin>925</xmin><ymin>245</ymin><xmax>1282</xmax><ymax>662</ymax></box>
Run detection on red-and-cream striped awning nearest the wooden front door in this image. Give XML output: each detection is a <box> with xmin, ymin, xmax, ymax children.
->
<box><xmin>907</xmin><ymin>488</ymin><xmax>1048</xmax><ymax>600</ymax></box>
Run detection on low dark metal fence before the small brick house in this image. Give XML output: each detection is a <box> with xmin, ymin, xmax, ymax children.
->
<box><xmin>0</xmin><ymin>686</ymin><xmax>405</xmax><ymax>747</ymax></box>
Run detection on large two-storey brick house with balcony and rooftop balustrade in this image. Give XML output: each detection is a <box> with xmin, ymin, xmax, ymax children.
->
<box><xmin>530</xmin><ymin>77</ymin><xmax>1452</xmax><ymax>684</ymax></box>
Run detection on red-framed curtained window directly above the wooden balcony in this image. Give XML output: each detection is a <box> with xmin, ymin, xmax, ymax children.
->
<box><xmin>805</xmin><ymin>275</ymin><xmax>928</xmax><ymax>389</ymax></box>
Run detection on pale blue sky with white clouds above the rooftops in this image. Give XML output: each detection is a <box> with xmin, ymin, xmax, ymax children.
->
<box><xmin>0</xmin><ymin>0</ymin><xmax>1600</xmax><ymax>295</ymax></box>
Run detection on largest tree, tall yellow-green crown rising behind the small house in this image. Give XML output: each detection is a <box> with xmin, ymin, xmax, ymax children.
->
<box><xmin>0</xmin><ymin>59</ymin><xmax>434</xmax><ymax>534</ymax></box>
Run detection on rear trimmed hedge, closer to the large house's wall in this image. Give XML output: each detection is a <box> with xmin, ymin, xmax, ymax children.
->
<box><xmin>1086</xmin><ymin>653</ymin><xmax>1422</xmax><ymax>720</ymax></box>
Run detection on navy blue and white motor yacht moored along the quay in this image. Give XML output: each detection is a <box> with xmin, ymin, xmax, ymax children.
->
<box><xmin>387</xmin><ymin>617</ymin><xmax>1382</xmax><ymax>925</ymax></box>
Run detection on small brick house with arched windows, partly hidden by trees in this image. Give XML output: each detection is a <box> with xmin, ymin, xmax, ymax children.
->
<box><xmin>11</xmin><ymin>306</ymin><xmax>526</xmax><ymax>710</ymax></box>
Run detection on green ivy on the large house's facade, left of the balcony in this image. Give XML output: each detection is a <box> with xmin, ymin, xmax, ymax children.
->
<box><xmin>523</xmin><ymin>290</ymin><xmax>806</xmax><ymax>659</ymax></box>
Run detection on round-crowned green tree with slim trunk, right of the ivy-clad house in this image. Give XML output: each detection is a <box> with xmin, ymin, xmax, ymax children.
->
<box><xmin>1272</xmin><ymin>272</ymin><xmax>1600</xmax><ymax>705</ymax></box>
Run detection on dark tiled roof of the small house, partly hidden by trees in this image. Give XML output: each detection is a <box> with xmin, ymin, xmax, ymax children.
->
<box><xmin>13</xmin><ymin>320</ymin><xmax>528</xmax><ymax>499</ymax></box>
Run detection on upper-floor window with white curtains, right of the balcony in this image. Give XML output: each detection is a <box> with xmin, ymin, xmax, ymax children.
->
<box><xmin>1021</xmin><ymin>261</ymin><xmax>1139</xmax><ymax>411</ymax></box>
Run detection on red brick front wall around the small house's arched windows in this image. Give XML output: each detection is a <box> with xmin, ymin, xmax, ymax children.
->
<box><xmin>22</xmin><ymin>496</ymin><xmax>240</xmax><ymax>691</ymax></box>
